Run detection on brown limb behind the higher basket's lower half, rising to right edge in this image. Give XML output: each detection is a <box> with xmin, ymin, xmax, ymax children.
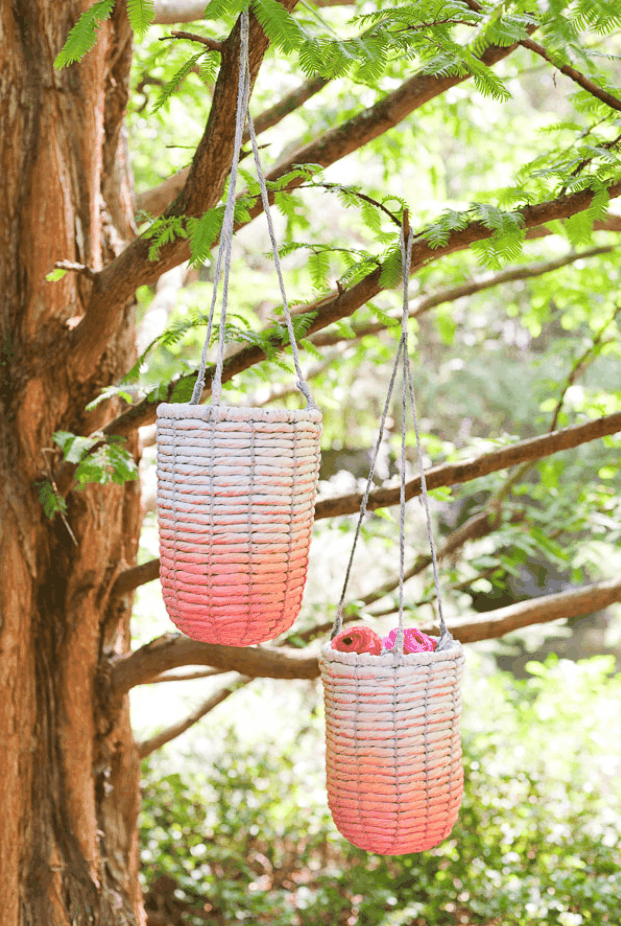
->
<box><xmin>111</xmin><ymin>412</ymin><xmax>621</xmax><ymax>595</ymax></box>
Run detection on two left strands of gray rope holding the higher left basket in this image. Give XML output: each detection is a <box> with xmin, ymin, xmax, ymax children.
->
<box><xmin>190</xmin><ymin>13</ymin><xmax>250</xmax><ymax>405</ymax></box>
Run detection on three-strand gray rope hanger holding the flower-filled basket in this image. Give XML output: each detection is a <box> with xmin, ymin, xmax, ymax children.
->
<box><xmin>331</xmin><ymin>213</ymin><xmax>453</xmax><ymax>657</ymax></box>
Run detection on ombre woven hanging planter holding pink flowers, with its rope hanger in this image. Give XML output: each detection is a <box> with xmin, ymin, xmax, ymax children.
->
<box><xmin>319</xmin><ymin>219</ymin><xmax>464</xmax><ymax>855</ymax></box>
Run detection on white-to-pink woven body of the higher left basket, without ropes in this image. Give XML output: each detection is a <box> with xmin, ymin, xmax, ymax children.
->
<box><xmin>157</xmin><ymin>404</ymin><xmax>321</xmax><ymax>646</ymax></box>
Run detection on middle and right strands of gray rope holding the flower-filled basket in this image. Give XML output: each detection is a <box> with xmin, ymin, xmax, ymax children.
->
<box><xmin>395</xmin><ymin>229</ymin><xmax>453</xmax><ymax>651</ymax></box>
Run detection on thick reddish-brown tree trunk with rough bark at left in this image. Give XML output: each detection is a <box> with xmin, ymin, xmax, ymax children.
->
<box><xmin>0</xmin><ymin>0</ymin><xmax>144</xmax><ymax>926</ymax></box>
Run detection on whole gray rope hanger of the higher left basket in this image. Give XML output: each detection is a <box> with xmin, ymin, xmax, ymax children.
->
<box><xmin>190</xmin><ymin>11</ymin><xmax>316</xmax><ymax>408</ymax></box>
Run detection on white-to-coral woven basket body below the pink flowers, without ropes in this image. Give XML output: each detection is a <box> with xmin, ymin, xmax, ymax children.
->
<box><xmin>319</xmin><ymin>642</ymin><xmax>464</xmax><ymax>855</ymax></box>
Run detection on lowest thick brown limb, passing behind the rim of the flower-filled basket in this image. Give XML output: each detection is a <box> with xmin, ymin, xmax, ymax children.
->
<box><xmin>110</xmin><ymin>579</ymin><xmax>621</xmax><ymax>696</ymax></box>
